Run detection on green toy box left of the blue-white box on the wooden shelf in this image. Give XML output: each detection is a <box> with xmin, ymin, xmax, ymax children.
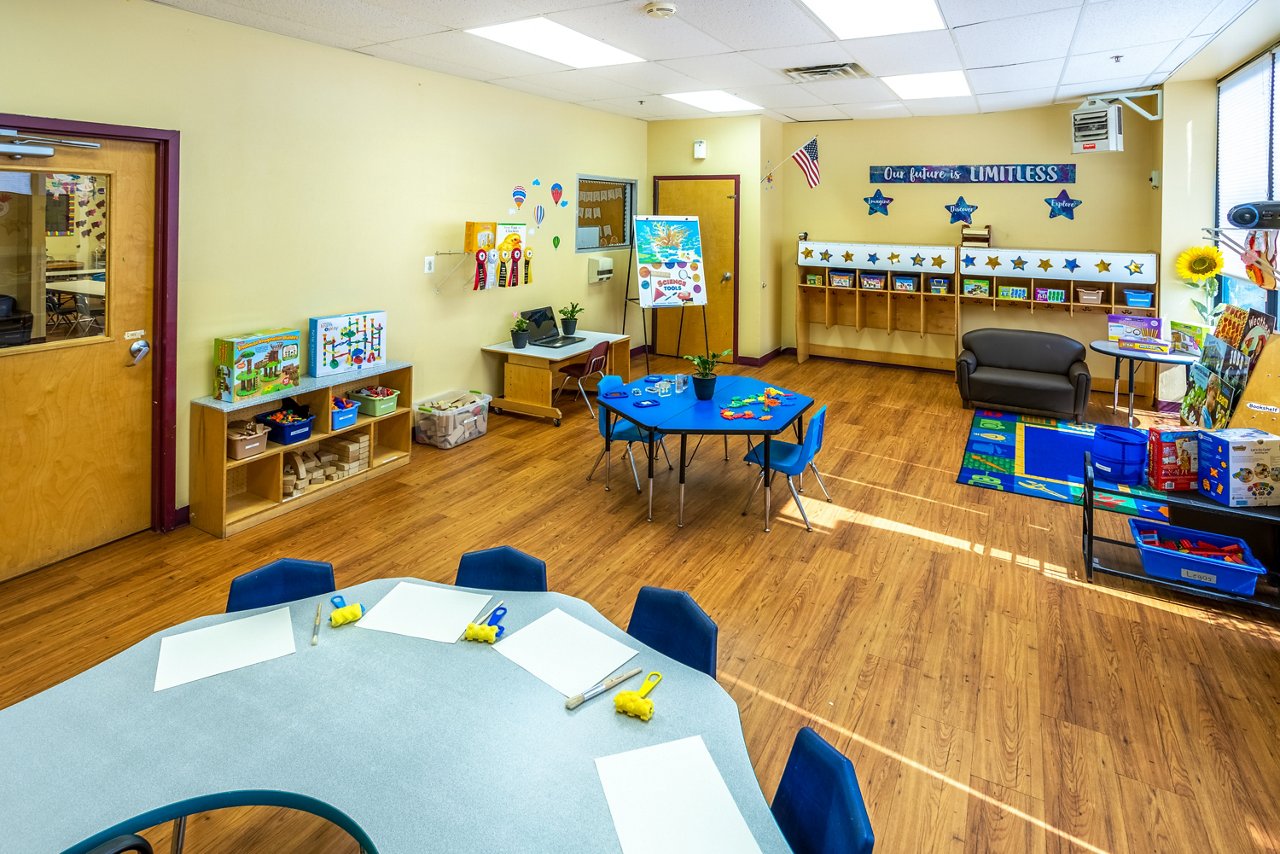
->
<box><xmin>214</xmin><ymin>329</ymin><xmax>302</xmax><ymax>403</ymax></box>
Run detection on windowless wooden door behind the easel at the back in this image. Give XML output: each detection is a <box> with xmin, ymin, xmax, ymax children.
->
<box><xmin>650</xmin><ymin>175</ymin><xmax>739</xmax><ymax>356</ymax></box>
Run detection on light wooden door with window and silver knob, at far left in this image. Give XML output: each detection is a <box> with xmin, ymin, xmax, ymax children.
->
<box><xmin>0</xmin><ymin>140</ymin><xmax>156</xmax><ymax>579</ymax></box>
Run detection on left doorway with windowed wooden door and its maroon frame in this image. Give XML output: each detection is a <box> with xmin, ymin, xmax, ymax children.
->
<box><xmin>0</xmin><ymin>115</ymin><xmax>182</xmax><ymax>580</ymax></box>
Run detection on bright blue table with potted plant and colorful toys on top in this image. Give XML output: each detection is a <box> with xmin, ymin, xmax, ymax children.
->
<box><xmin>599</xmin><ymin>375</ymin><xmax>813</xmax><ymax>531</ymax></box>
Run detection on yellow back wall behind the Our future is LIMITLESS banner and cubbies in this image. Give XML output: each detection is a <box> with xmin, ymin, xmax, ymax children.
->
<box><xmin>771</xmin><ymin>105</ymin><xmax>1160</xmax><ymax>378</ymax></box>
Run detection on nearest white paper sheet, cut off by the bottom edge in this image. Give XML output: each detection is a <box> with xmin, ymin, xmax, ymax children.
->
<box><xmin>595</xmin><ymin>735</ymin><xmax>760</xmax><ymax>854</ymax></box>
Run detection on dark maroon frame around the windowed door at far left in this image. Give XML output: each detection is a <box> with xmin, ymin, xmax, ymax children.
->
<box><xmin>0</xmin><ymin>113</ymin><xmax>188</xmax><ymax>531</ymax></box>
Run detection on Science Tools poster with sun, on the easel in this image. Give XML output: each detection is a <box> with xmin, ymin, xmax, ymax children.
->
<box><xmin>635</xmin><ymin>216</ymin><xmax>707</xmax><ymax>309</ymax></box>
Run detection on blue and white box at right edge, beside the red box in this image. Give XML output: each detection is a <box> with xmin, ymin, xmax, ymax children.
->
<box><xmin>1198</xmin><ymin>428</ymin><xmax>1280</xmax><ymax>507</ymax></box>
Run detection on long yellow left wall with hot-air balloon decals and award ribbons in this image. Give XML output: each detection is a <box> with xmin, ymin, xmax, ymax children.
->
<box><xmin>3</xmin><ymin>0</ymin><xmax>645</xmax><ymax>504</ymax></box>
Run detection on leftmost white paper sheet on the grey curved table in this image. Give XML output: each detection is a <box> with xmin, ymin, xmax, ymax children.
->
<box><xmin>155</xmin><ymin>607</ymin><xmax>296</xmax><ymax>691</ymax></box>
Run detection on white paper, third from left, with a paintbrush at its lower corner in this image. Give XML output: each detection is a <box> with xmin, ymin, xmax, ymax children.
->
<box><xmin>494</xmin><ymin>608</ymin><xmax>636</xmax><ymax>697</ymax></box>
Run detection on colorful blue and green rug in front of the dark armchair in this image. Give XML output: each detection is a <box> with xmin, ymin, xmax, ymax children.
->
<box><xmin>956</xmin><ymin>410</ymin><xmax>1169</xmax><ymax>521</ymax></box>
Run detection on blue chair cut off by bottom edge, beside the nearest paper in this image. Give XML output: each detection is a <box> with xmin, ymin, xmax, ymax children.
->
<box><xmin>773</xmin><ymin>727</ymin><xmax>876</xmax><ymax>854</ymax></box>
